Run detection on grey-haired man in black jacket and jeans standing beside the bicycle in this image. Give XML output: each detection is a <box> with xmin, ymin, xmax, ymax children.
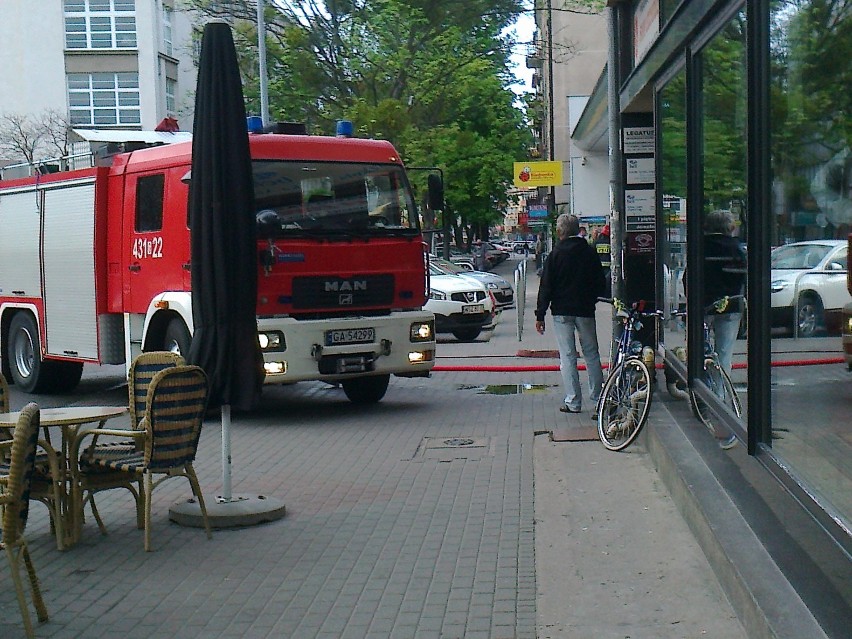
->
<box><xmin>535</xmin><ymin>213</ymin><xmax>605</xmax><ymax>418</ymax></box>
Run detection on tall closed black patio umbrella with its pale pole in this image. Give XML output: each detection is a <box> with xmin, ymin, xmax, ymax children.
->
<box><xmin>187</xmin><ymin>22</ymin><xmax>263</xmax><ymax>499</ymax></box>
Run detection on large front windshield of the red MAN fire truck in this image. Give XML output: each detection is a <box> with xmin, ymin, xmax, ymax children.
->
<box><xmin>253</xmin><ymin>160</ymin><xmax>418</xmax><ymax>239</ymax></box>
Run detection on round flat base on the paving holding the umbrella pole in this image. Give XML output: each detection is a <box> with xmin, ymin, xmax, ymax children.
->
<box><xmin>169</xmin><ymin>495</ymin><xmax>286</xmax><ymax>528</ymax></box>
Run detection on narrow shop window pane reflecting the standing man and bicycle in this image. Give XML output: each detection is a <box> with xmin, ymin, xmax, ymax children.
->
<box><xmin>690</xmin><ymin>11</ymin><xmax>750</xmax><ymax>444</ymax></box>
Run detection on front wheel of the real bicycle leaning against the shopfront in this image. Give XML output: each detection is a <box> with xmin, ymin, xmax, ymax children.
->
<box><xmin>598</xmin><ymin>359</ymin><xmax>651</xmax><ymax>450</ymax></box>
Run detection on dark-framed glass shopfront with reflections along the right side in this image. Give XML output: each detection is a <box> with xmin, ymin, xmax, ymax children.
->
<box><xmin>604</xmin><ymin>0</ymin><xmax>852</xmax><ymax>553</ymax></box>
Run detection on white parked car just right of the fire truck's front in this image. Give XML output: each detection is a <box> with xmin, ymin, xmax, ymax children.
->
<box><xmin>425</xmin><ymin>264</ymin><xmax>496</xmax><ymax>342</ymax></box>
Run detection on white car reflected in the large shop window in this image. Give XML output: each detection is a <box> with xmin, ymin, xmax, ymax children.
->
<box><xmin>770</xmin><ymin>240</ymin><xmax>852</xmax><ymax>337</ymax></box>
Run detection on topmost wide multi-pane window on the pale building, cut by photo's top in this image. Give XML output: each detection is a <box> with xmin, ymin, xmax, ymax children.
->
<box><xmin>65</xmin><ymin>0</ymin><xmax>136</xmax><ymax>49</ymax></box>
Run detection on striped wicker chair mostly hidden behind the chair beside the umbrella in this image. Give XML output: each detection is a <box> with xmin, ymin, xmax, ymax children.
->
<box><xmin>82</xmin><ymin>351</ymin><xmax>186</xmax><ymax>535</ymax></box>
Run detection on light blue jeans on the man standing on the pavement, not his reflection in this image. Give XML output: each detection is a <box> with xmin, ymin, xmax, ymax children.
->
<box><xmin>553</xmin><ymin>315</ymin><xmax>603</xmax><ymax>411</ymax></box>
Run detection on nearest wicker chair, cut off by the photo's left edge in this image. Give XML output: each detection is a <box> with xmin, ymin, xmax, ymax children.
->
<box><xmin>0</xmin><ymin>403</ymin><xmax>47</xmax><ymax>637</ymax></box>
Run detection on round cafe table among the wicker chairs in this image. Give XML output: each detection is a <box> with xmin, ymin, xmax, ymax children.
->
<box><xmin>0</xmin><ymin>406</ymin><xmax>128</xmax><ymax>550</ymax></box>
